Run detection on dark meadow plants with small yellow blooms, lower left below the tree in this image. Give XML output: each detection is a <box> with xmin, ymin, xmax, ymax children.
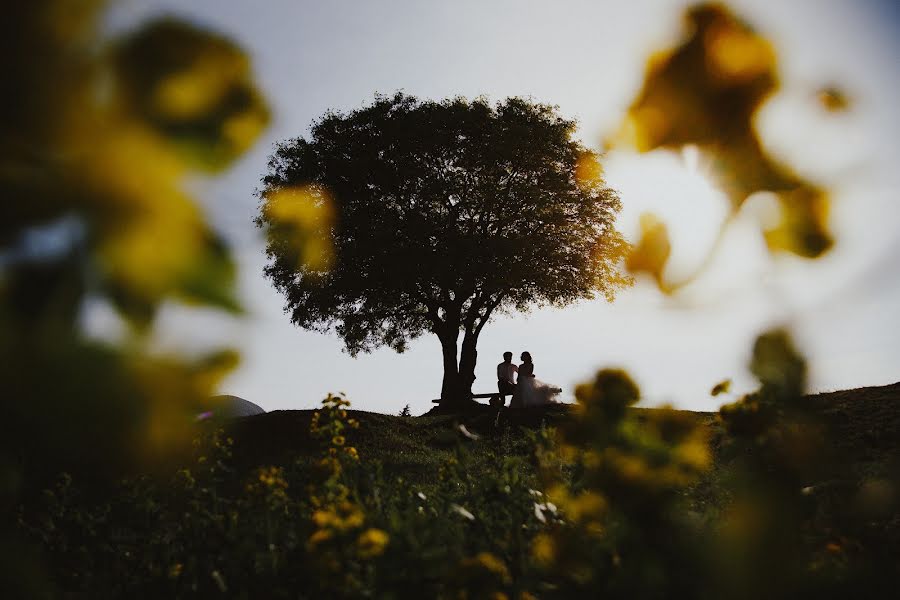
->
<box><xmin>20</xmin><ymin>396</ymin><xmax>556</xmax><ymax>598</ymax></box>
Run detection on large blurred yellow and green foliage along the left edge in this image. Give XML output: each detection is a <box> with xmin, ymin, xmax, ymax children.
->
<box><xmin>0</xmin><ymin>0</ymin><xmax>268</xmax><ymax>596</ymax></box>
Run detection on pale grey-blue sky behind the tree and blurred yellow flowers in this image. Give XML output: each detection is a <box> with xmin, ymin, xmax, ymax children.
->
<box><xmin>98</xmin><ymin>0</ymin><xmax>900</xmax><ymax>414</ymax></box>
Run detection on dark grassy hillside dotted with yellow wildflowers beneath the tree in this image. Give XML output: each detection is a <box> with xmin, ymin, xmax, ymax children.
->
<box><xmin>20</xmin><ymin>384</ymin><xmax>900</xmax><ymax>598</ymax></box>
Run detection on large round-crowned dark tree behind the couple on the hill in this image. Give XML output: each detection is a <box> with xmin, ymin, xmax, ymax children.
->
<box><xmin>256</xmin><ymin>93</ymin><xmax>630</xmax><ymax>402</ymax></box>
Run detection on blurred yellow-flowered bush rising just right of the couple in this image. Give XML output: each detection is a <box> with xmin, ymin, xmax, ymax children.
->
<box><xmin>532</xmin><ymin>370</ymin><xmax>712</xmax><ymax>597</ymax></box>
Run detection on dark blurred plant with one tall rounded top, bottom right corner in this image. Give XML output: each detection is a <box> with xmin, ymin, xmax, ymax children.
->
<box><xmin>713</xmin><ymin>330</ymin><xmax>898</xmax><ymax>598</ymax></box>
